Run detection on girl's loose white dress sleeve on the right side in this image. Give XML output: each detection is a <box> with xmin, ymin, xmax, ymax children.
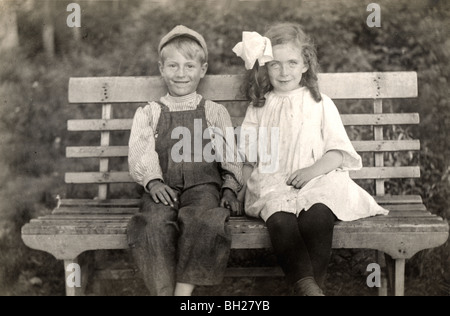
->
<box><xmin>322</xmin><ymin>95</ymin><xmax>362</xmax><ymax>170</ymax></box>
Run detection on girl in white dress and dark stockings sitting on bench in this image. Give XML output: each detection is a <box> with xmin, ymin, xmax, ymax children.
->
<box><xmin>233</xmin><ymin>23</ymin><xmax>388</xmax><ymax>296</ymax></box>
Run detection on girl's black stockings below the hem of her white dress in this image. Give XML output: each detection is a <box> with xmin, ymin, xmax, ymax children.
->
<box><xmin>266</xmin><ymin>204</ymin><xmax>336</xmax><ymax>286</ymax></box>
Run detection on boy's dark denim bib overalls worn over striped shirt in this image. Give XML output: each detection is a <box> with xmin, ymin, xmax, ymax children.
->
<box><xmin>128</xmin><ymin>99</ymin><xmax>231</xmax><ymax>295</ymax></box>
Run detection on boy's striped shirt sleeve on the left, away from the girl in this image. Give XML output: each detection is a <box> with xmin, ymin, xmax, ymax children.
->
<box><xmin>128</xmin><ymin>104</ymin><xmax>163</xmax><ymax>191</ymax></box>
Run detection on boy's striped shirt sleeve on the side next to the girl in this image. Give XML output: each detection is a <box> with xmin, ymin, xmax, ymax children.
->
<box><xmin>205</xmin><ymin>101</ymin><xmax>243</xmax><ymax>194</ymax></box>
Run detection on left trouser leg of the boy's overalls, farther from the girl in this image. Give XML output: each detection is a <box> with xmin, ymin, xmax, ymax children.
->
<box><xmin>127</xmin><ymin>193</ymin><xmax>178</xmax><ymax>296</ymax></box>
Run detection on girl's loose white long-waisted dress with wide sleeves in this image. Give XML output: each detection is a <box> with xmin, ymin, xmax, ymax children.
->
<box><xmin>241</xmin><ymin>87</ymin><xmax>388</xmax><ymax>221</ymax></box>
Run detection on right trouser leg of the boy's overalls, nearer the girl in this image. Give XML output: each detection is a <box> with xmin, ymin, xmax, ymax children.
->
<box><xmin>177</xmin><ymin>184</ymin><xmax>231</xmax><ymax>285</ymax></box>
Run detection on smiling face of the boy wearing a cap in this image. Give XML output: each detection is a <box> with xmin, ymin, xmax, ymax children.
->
<box><xmin>159</xmin><ymin>47</ymin><xmax>208</xmax><ymax>97</ymax></box>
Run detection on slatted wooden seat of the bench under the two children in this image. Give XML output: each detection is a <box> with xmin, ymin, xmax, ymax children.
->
<box><xmin>22</xmin><ymin>196</ymin><xmax>449</xmax><ymax>260</ymax></box>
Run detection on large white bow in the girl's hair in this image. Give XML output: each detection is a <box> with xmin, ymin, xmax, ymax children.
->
<box><xmin>233</xmin><ymin>32</ymin><xmax>273</xmax><ymax>70</ymax></box>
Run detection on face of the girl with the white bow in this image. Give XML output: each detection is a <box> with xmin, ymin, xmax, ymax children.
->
<box><xmin>267</xmin><ymin>42</ymin><xmax>308</xmax><ymax>92</ymax></box>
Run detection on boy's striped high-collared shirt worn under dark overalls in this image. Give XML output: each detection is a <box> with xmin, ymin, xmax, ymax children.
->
<box><xmin>128</xmin><ymin>92</ymin><xmax>243</xmax><ymax>193</ymax></box>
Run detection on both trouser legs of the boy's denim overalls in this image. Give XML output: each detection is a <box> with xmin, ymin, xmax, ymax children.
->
<box><xmin>128</xmin><ymin>184</ymin><xmax>231</xmax><ymax>296</ymax></box>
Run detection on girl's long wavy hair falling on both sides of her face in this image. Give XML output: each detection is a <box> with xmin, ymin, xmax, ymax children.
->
<box><xmin>244</xmin><ymin>23</ymin><xmax>322</xmax><ymax>106</ymax></box>
